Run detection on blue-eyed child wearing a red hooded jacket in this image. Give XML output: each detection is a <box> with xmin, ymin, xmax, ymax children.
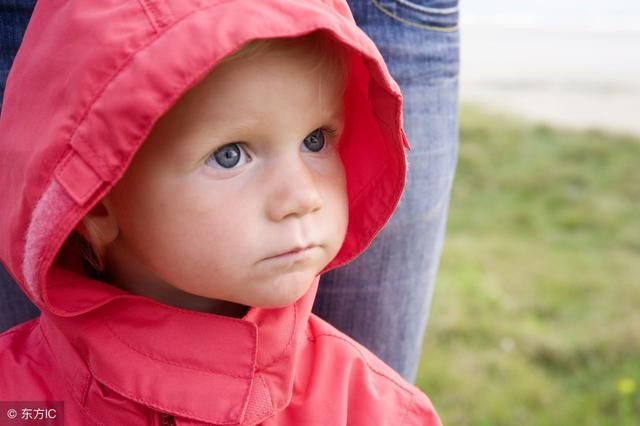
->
<box><xmin>0</xmin><ymin>0</ymin><xmax>439</xmax><ymax>425</ymax></box>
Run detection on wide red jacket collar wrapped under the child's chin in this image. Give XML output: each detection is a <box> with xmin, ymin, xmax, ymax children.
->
<box><xmin>41</xmin><ymin>271</ymin><xmax>318</xmax><ymax>425</ymax></box>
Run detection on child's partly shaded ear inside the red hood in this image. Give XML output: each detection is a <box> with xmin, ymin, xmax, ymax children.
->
<box><xmin>76</xmin><ymin>195</ymin><xmax>120</xmax><ymax>258</ymax></box>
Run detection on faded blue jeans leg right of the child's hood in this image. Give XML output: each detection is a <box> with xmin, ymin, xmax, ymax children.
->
<box><xmin>314</xmin><ymin>0</ymin><xmax>459</xmax><ymax>381</ymax></box>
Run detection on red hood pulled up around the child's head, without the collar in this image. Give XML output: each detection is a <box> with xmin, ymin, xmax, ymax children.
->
<box><xmin>0</xmin><ymin>0</ymin><xmax>408</xmax><ymax>315</ymax></box>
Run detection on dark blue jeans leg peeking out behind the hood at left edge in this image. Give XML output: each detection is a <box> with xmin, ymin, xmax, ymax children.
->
<box><xmin>0</xmin><ymin>0</ymin><xmax>38</xmax><ymax>332</ymax></box>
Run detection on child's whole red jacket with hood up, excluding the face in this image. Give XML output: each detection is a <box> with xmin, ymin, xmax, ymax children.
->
<box><xmin>0</xmin><ymin>0</ymin><xmax>440</xmax><ymax>426</ymax></box>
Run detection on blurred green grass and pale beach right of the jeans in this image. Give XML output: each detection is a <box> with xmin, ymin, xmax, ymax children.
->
<box><xmin>418</xmin><ymin>0</ymin><xmax>640</xmax><ymax>426</ymax></box>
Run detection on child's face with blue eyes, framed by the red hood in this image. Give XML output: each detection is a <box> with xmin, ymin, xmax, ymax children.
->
<box><xmin>105</xmin><ymin>43</ymin><xmax>348</xmax><ymax>309</ymax></box>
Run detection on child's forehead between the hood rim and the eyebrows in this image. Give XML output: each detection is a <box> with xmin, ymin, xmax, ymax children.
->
<box><xmin>134</xmin><ymin>43</ymin><xmax>345</xmax><ymax>158</ymax></box>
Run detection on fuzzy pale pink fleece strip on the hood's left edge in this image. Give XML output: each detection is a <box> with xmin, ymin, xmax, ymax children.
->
<box><xmin>22</xmin><ymin>179</ymin><xmax>76</xmax><ymax>302</ymax></box>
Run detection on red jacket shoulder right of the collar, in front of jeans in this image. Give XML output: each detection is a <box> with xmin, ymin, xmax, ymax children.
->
<box><xmin>302</xmin><ymin>316</ymin><xmax>441</xmax><ymax>426</ymax></box>
